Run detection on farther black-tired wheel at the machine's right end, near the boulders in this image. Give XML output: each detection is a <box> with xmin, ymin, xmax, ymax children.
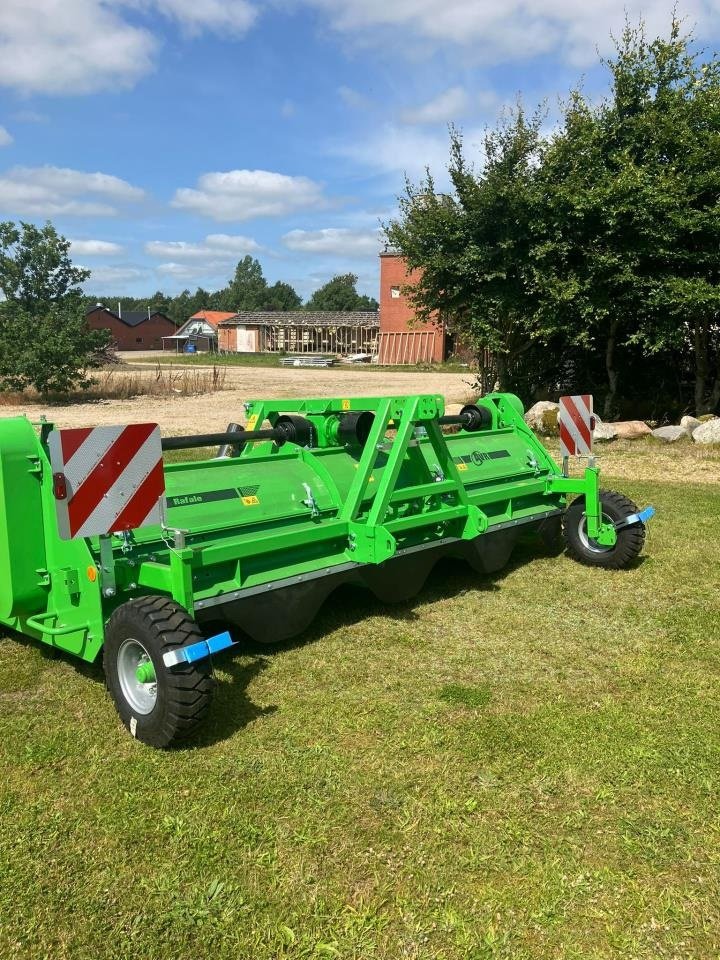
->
<box><xmin>563</xmin><ymin>490</ymin><xmax>645</xmax><ymax>570</ymax></box>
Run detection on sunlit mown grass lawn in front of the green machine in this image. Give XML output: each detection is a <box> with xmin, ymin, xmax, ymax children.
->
<box><xmin>0</xmin><ymin>453</ymin><xmax>720</xmax><ymax>960</ymax></box>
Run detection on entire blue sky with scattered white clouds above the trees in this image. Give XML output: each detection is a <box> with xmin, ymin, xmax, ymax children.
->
<box><xmin>0</xmin><ymin>0</ymin><xmax>720</xmax><ymax>297</ymax></box>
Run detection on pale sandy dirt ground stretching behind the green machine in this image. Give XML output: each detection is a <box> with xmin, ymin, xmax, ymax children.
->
<box><xmin>0</xmin><ymin>367</ymin><xmax>472</xmax><ymax>433</ymax></box>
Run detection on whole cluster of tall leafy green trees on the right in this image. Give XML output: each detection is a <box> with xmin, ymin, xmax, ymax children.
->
<box><xmin>386</xmin><ymin>18</ymin><xmax>720</xmax><ymax>417</ymax></box>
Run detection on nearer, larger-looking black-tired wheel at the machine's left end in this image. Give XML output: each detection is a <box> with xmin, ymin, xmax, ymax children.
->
<box><xmin>103</xmin><ymin>596</ymin><xmax>215</xmax><ymax>748</ymax></box>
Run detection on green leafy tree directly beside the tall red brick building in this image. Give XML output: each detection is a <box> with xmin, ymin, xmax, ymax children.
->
<box><xmin>386</xmin><ymin>114</ymin><xmax>543</xmax><ymax>389</ymax></box>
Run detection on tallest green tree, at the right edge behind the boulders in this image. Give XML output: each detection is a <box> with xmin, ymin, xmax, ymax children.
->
<box><xmin>535</xmin><ymin>21</ymin><xmax>720</xmax><ymax>416</ymax></box>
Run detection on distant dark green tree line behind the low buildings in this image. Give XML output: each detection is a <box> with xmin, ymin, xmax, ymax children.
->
<box><xmin>87</xmin><ymin>255</ymin><xmax>378</xmax><ymax>325</ymax></box>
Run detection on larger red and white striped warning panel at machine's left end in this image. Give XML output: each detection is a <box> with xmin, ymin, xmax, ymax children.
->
<box><xmin>48</xmin><ymin>423</ymin><xmax>165</xmax><ymax>540</ymax></box>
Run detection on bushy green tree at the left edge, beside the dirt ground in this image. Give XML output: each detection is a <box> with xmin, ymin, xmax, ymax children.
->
<box><xmin>0</xmin><ymin>222</ymin><xmax>107</xmax><ymax>394</ymax></box>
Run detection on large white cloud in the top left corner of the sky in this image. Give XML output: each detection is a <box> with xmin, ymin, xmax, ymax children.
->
<box><xmin>0</xmin><ymin>0</ymin><xmax>255</xmax><ymax>95</ymax></box>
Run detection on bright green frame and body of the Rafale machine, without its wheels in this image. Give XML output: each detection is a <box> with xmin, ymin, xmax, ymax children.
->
<box><xmin>0</xmin><ymin>393</ymin><xmax>650</xmax><ymax>748</ymax></box>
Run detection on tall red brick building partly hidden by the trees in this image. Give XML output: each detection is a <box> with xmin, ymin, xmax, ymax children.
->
<box><xmin>380</xmin><ymin>253</ymin><xmax>445</xmax><ymax>363</ymax></box>
